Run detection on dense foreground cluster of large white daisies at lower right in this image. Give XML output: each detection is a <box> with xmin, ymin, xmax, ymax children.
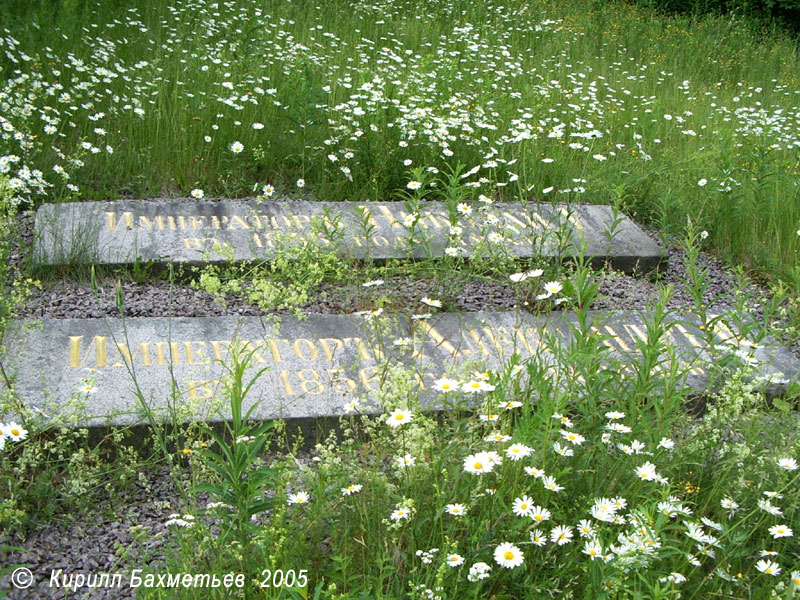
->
<box><xmin>370</xmin><ymin>394</ymin><xmax>798</xmax><ymax>585</ymax></box>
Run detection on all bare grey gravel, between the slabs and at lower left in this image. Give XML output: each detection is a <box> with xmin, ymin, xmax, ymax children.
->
<box><xmin>0</xmin><ymin>216</ymin><xmax>780</xmax><ymax>600</ymax></box>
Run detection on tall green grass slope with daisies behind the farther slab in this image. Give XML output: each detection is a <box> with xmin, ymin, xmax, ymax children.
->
<box><xmin>0</xmin><ymin>0</ymin><xmax>800</xmax><ymax>275</ymax></box>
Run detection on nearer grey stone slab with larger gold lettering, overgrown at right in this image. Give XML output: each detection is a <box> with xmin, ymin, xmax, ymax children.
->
<box><xmin>3</xmin><ymin>312</ymin><xmax>800</xmax><ymax>425</ymax></box>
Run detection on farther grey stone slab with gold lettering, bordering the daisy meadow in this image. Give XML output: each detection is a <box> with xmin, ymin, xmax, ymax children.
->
<box><xmin>36</xmin><ymin>200</ymin><xmax>664</xmax><ymax>272</ymax></box>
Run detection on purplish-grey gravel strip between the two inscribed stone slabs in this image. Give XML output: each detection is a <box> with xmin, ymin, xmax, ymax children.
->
<box><xmin>21</xmin><ymin>247</ymin><xmax>757</xmax><ymax>319</ymax></box>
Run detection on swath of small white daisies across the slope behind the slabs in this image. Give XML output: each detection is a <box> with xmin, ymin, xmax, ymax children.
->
<box><xmin>0</xmin><ymin>0</ymin><xmax>800</xmax><ymax>220</ymax></box>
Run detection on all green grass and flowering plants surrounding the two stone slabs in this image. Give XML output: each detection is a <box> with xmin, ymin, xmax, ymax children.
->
<box><xmin>0</xmin><ymin>0</ymin><xmax>800</xmax><ymax>600</ymax></box>
